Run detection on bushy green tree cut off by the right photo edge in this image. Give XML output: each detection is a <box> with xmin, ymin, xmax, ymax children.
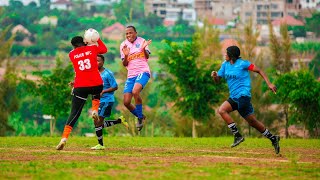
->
<box><xmin>276</xmin><ymin>70</ymin><xmax>320</xmax><ymax>137</ymax></box>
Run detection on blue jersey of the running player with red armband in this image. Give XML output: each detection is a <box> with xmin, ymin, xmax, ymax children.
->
<box><xmin>218</xmin><ymin>59</ymin><xmax>251</xmax><ymax>98</ymax></box>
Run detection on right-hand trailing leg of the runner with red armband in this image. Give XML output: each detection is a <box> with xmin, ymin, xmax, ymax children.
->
<box><xmin>238</xmin><ymin>97</ymin><xmax>280</xmax><ymax>154</ymax></box>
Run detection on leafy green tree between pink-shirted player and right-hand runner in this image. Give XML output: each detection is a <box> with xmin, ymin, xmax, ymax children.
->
<box><xmin>159</xmin><ymin>36</ymin><xmax>225</xmax><ymax>137</ymax></box>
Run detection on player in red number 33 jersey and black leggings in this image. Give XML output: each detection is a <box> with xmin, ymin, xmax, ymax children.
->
<box><xmin>56</xmin><ymin>36</ymin><xmax>108</xmax><ymax>150</ymax></box>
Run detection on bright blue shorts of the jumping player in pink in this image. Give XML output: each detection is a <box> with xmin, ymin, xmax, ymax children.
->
<box><xmin>123</xmin><ymin>72</ymin><xmax>150</xmax><ymax>93</ymax></box>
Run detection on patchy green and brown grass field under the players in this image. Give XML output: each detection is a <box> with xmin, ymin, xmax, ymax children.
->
<box><xmin>0</xmin><ymin>137</ymin><xmax>320</xmax><ymax>180</ymax></box>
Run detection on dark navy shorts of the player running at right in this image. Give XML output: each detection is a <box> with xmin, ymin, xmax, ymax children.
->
<box><xmin>227</xmin><ymin>96</ymin><xmax>254</xmax><ymax>118</ymax></box>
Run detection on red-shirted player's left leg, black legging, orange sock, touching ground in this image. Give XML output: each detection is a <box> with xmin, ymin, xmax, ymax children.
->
<box><xmin>56</xmin><ymin>88</ymin><xmax>88</xmax><ymax>150</ymax></box>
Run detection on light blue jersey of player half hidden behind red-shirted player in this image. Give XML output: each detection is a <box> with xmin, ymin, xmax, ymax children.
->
<box><xmin>100</xmin><ymin>69</ymin><xmax>118</xmax><ymax>102</ymax></box>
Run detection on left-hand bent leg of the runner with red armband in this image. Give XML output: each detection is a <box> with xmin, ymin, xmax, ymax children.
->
<box><xmin>218</xmin><ymin>98</ymin><xmax>244</xmax><ymax>147</ymax></box>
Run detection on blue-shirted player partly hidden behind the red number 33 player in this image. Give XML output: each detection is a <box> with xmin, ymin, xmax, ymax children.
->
<box><xmin>91</xmin><ymin>54</ymin><xmax>129</xmax><ymax>150</ymax></box>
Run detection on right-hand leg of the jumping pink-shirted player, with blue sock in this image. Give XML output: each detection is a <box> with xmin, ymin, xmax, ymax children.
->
<box><xmin>132</xmin><ymin>73</ymin><xmax>150</xmax><ymax>131</ymax></box>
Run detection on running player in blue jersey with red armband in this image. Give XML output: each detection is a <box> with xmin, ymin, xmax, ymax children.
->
<box><xmin>211</xmin><ymin>46</ymin><xmax>280</xmax><ymax>154</ymax></box>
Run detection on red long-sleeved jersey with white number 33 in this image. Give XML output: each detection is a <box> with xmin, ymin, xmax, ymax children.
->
<box><xmin>69</xmin><ymin>39</ymin><xmax>108</xmax><ymax>87</ymax></box>
